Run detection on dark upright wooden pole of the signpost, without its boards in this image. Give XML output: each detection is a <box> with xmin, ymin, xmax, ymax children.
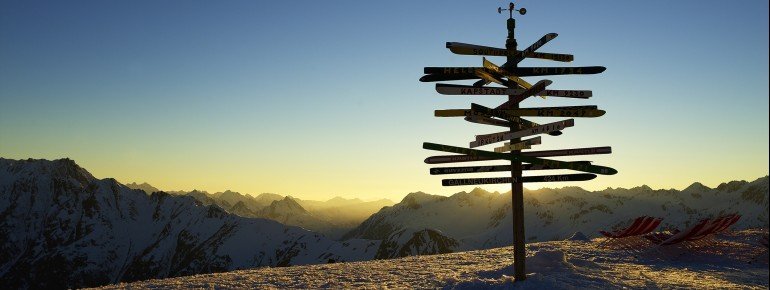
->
<box><xmin>505</xmin><ymin>17</ymin><xmax>527</xmax><ymax>281</ymax></box>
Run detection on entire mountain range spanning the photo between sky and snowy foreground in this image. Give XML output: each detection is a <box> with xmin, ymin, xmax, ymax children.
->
<box><xmin>0</xmin><ymin>158</ymin><xmax>768</xmax><ymax>289</ymax></box>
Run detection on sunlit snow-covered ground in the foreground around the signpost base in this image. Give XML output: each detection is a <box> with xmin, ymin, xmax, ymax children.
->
<box><xmin>94</xmin><ymin>229</ymin><xmax>769</xmax><ymax>289</ymax></box>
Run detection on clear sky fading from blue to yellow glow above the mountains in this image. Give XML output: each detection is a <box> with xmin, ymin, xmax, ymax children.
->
<box><xmin>0</xmin><ymin>0</ymin><xmax>770</xmax><ymax>200</ymax></box>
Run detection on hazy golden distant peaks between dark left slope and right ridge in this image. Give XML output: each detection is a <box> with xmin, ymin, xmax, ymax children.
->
<box><xmin>126</xmin><ymin>183</ymin><xmax>395</xmax><ymax>239</ymax></box>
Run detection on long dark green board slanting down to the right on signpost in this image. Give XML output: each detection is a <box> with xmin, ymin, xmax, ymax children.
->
<box><xmin>422</xmin><ymin>142</ymin><xmax>618</xmax><ymax>175</ymax></box>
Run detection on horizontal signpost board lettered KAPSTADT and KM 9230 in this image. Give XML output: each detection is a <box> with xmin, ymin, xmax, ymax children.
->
<box><xmin>436</xmin><ymin>84</ymin><xmax>592</xmax><ymax>99</ymax></box>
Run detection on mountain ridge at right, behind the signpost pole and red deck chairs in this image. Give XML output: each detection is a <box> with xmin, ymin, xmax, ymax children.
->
<box><xmin>344</xmin><ymin>176</ymin><xmax>769</xmax><ymax>250</ymax></box>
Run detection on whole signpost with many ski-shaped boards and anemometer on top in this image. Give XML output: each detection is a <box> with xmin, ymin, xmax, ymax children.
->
<box><xmin>420</xmin><ymin>3</ymin><xmax>617</xmax><ymax>281</ymax></box>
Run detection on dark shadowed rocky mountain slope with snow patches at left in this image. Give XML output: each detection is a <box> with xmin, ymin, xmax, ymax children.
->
<box><xmin>0</xmin><ymin>158</ymin><xmax>380</xmax><ymax>289</ymax></box>
